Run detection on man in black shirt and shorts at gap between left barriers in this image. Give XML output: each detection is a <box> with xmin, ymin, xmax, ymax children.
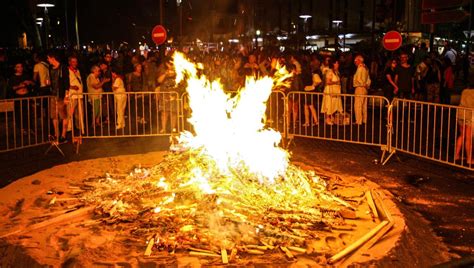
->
<box><xmin>47</xmin><ymin>53</ymin><xmax>69</xmax><ymax>143</ymax></box>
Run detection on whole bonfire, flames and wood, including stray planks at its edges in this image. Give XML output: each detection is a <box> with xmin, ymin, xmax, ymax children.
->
<box><xmin>3</xmin><ymin>54</ymin><xmax>393</xmax><ymax>264</ymax></box>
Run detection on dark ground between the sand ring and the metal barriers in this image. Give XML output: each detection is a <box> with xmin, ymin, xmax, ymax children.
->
<box><xmin>0</xmin><ymin>138</ymin><xmax>474</xmax><ymax>267</ymax></box>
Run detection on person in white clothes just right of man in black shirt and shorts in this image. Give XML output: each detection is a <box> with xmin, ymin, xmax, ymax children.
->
<box><xmin>68</xmin><ymin>56</ymin><xmax>84</xmax><ymax>134</ymax></box>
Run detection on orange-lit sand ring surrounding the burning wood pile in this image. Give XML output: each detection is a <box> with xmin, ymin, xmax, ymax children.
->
<box><xmin>0</xmin><ymin>152</ymin><xmax>412</xmax><ymax>267</ymax></box>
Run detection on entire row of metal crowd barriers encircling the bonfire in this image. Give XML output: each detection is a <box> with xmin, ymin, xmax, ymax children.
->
<box><xmin>0</xmin><ymin>91</ymin><xmax>474</xmax><ymax>173</ymax></box>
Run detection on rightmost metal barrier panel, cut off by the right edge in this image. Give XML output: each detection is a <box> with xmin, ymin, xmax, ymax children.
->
<box><xmin>391</xmin><ymin>99</ymin><xmax>474</xmax><ymax>170</ymax></box>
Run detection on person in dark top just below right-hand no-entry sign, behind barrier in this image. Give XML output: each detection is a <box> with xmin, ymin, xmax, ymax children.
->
<box><xmin>395</xmin><ymin>52</ymin><xmax>415</xmax><ymax>99</ymax></box>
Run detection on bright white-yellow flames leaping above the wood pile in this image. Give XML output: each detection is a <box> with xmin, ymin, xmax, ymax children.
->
<box><xmin>174</xmin><ymin>53</ymin><xmax>289</xmax><ymax>183</ymax></box>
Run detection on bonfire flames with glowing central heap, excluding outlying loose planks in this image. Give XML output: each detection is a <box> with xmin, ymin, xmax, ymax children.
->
<box><xmin>84</xmin><ymin>53</ymin><xmax>350</xmax><ymax>253</ymax></box>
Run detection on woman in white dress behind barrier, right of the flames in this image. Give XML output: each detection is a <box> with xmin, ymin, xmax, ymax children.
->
<box><xmin>321</xmin><ymin>60</ymin><xmax>344</xmax><ymax>125</ymax></box>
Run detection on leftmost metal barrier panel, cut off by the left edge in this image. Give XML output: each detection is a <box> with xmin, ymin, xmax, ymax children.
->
<box><xmin>0</xmin><ymin>96</ymin><xmax>51</xmax><ymax>152</ymax></box>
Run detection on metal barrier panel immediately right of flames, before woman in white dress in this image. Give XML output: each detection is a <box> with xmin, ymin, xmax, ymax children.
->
<box><xmin>286</xmin><ymin>92</ymin><xmax>389</xmax><ymax>150</ymax></box>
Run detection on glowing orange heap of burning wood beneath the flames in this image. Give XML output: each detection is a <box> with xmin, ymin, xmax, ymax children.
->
<box><xmin>81</xmin><ymin>152</ymin><xmax>355</xmax><ymax>262</ymax></box>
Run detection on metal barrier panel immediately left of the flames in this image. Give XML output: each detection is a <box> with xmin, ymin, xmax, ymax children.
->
<box><xmin>68</xmin><ymin>92</ymin><xmax>180</xmax><ymax>138</ymax></box>
